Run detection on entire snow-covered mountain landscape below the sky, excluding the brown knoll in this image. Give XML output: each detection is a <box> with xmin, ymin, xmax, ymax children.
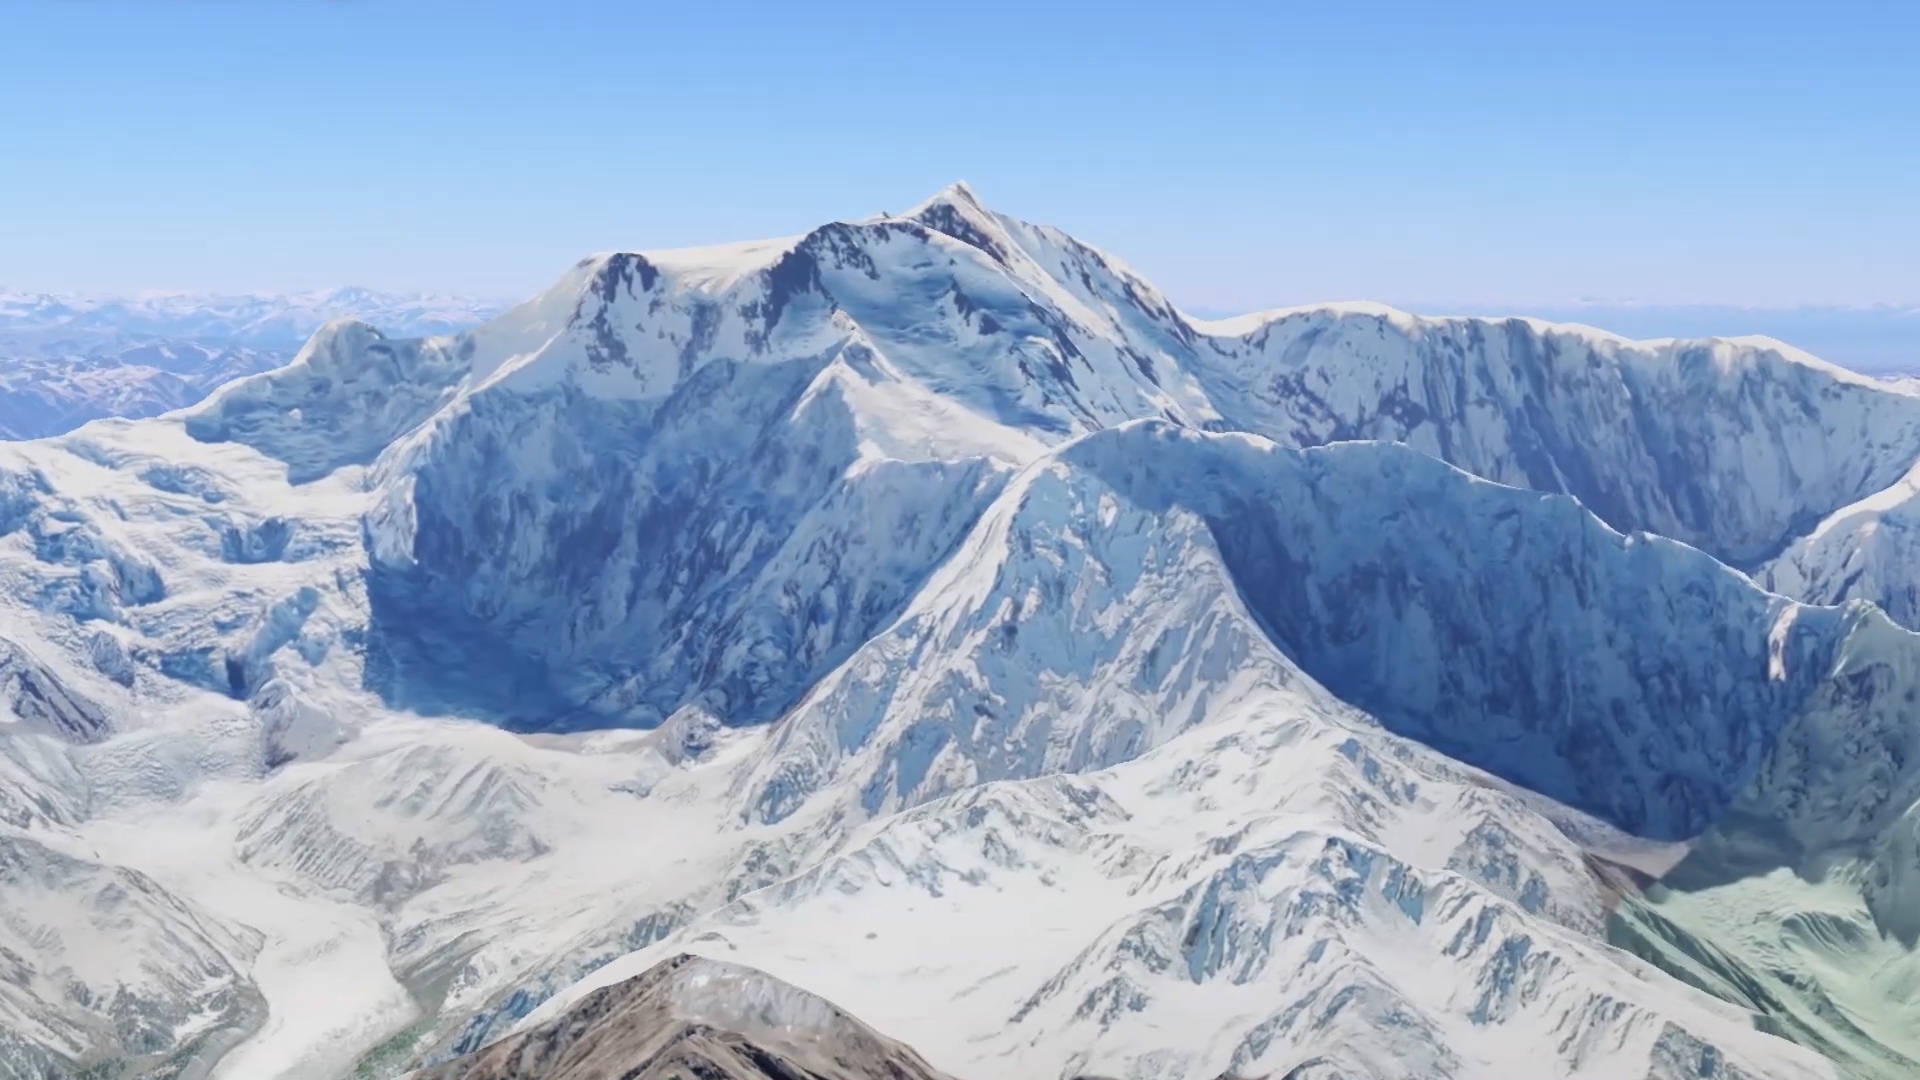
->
<box><xmin>0</xmin><ymin>186</ymin><xmax>1920</xmax><ymax>1080</ymax></box>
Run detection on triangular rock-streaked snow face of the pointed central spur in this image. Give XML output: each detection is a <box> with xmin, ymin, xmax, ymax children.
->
<box><xmin>745</xmin><ymin>434</ymin><xmax>1327</xmax><ymax>821</ymax></box>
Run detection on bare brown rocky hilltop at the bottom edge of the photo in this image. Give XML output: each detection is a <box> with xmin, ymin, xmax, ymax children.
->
<box><xmin>415</xmin><ymin>955</ymin><xmax>952</xmax><ymax>1080</ymax></box>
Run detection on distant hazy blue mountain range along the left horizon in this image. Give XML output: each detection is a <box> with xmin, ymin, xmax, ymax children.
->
<box><xmin>0</xmin><ymin>288</ymin><xmax>503</xmax><ymax>438</ymax></box>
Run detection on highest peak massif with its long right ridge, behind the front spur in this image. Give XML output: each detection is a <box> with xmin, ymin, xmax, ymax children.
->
<box><xmin>186</xmin><ymin>186</ymin><xmax>1920</xmax><ymax>728</ymax></box>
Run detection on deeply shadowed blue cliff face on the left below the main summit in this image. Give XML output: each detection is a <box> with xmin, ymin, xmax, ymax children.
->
<box><xmin>369</xmin><ymin>349</ymin><xmax>1002</xmax><ymax>726</ymax></box>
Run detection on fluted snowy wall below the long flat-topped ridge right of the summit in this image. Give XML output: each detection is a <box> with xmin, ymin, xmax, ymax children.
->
<box><xmin>1200</xmin><ymin>309</ymin><xmax>1920</xmax><ymax>567</ymax></box>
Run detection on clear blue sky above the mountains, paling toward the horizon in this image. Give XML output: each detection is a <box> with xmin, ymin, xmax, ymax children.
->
<box><xmin>0</xmin><ymin>0</ymin><xmax>1920</xmax><ymax>311</ymax></box>
